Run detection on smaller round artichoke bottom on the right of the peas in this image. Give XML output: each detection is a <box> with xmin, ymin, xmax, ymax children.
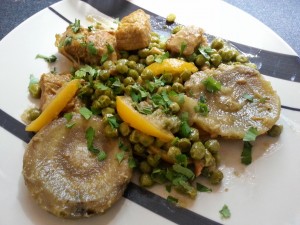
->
<box><xmin>183</xmin><ymin>64</ymin><xmax>281</xmax><ymax>139</ymax></box>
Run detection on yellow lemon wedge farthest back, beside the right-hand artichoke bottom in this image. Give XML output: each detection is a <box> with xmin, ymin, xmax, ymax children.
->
<box><xmin>145</xmin><ymin>58</ymin><xmax>198</xmax><ymax>76</ymax></box>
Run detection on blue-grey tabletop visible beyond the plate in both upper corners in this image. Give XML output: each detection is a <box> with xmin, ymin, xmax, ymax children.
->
<box><xmin>0</xmin><ymin>0</ymin><xmax>300</xmax><ymax>55</ymax></box>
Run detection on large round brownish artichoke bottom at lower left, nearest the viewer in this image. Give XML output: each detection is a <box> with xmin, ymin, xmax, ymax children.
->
<box><xmin>23</xmin><ymin>114</ymin><xmax>132</xmax><ymax>218</ymax></box>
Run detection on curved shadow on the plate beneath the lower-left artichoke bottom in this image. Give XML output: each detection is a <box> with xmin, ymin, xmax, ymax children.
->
<box><xmin>17</xmin><ymin>171</ymin><xmax>126</xmax><ymax>225</ymax></box>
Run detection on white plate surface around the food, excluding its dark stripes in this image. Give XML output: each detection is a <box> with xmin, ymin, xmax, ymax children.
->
<box><xmin>0</xmin><ymin>0</ymin><xmax>300</xmax><ymax>225</ymax></box>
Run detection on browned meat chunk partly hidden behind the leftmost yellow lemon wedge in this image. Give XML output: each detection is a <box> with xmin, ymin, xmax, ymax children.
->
<box><xmin>40</xmin><ymin>73</ymin><xmax>83</xmax><ymax>112</ymax></box>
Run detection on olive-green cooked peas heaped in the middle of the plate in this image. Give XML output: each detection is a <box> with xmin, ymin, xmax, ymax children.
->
<box><xmin>28</xmin><ymin>27</ymin><xmax>254</xmax><ymax>195</ymax></box>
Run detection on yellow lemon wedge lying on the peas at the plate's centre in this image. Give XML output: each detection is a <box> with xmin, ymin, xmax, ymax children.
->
<box><xmin>116</xmin><ymin>96</ymin><xmax>174</xmax><ymax>142</ymax></box>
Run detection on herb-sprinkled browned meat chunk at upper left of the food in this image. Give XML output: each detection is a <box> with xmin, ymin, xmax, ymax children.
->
<box><xmin>55</xmin><ymin>26</ymin><xmax>117</xmax><ymax>65</ymax></box>
